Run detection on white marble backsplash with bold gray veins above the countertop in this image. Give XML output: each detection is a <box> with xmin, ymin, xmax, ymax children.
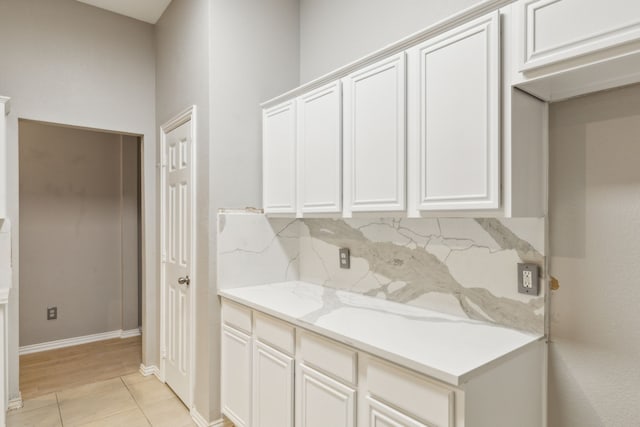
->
<box><xmin>218</xmin><ymin>212</ymin><xmax>545</xmax><ymax>333</ymax></box>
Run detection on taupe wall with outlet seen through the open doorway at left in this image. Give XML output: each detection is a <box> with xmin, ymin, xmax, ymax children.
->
<box><xmin>20</xmin><ymin>121</ymin><xmax>138</xmax><ymax>346</ymax></box>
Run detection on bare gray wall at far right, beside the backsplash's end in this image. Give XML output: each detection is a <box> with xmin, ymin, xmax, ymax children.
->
<box><xmin>549</xmin><ymin>86</ymin><xmax>640</xmax><ymax>427</ymax></box>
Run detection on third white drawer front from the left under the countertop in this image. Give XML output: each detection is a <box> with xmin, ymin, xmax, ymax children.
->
<box><xmin>300</xmin><ymin>332</ymin><xmax>357</xmax><ymax>384</ymax></box>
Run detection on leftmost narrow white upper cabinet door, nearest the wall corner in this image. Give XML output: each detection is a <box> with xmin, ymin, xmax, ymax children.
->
<box><xmin>262</xmin><ymin>100</ymin><xmax>296</xmax><ymax>214</ymax></box>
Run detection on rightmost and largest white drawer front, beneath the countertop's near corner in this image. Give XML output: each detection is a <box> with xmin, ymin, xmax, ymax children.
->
<box><xmin>366</xmin><ymin>358</ymin><xmax>454</xmax><ymax>427</ymax></box>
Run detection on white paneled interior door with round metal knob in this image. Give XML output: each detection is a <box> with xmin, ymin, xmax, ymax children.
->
<box><xmin>163</xmin><ymin>121</ymin><xmax>193</xmax><ymax>406</ymax></box>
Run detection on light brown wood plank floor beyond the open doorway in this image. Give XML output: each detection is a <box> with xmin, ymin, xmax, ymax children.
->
<box><xmin>20</xmin><ymin>337</ymin><xmax>142</xmax><ymax>400</ymax></box>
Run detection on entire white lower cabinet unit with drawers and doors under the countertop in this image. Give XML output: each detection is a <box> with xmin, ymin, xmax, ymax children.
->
<box><xmin>221</xmin><ymin>299</ymin><xmax>546</xmax><ymax>427</ymax></box>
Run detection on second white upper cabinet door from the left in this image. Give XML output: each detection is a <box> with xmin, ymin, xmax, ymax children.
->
<box><xmin>297</xmin><ymin>81</ymin><xmax>342</xmax><ymax>213</ymax></box>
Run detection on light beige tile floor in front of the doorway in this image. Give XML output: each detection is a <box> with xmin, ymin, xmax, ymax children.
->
<box><xmin>7</xmin><ymin>373</ymin><xmax>196</xmax><ymax>427</ymax></box>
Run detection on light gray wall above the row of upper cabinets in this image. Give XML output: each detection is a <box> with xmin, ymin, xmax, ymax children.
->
<box><xmin>300</xmin><ymin>0</ymin><xmax>480</xmax><ymax>83</ymax></box>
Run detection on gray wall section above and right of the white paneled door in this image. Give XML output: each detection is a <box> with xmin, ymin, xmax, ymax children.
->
<box><xmin>155</xmin><ymin>0</ymin><xmax>212</xmax><ymax>417</ymax></box>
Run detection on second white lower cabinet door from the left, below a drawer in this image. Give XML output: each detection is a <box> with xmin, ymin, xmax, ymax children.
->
<box><xmin>252</xmin><ymin>341</ymin><xmax>294</xmax><ymax>427</ymax></box>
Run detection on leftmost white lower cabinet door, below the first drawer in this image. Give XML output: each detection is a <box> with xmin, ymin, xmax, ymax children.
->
<box><xmin>221</xmin><ymin>325</ymin><xmax>251</xmax><ymax>427</ymax></box>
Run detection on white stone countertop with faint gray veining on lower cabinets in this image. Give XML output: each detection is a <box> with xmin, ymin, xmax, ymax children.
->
<box><xmin>219</xmin><ymin>282</ymin><xmax>543</xmax><ymax>386</ymax></box>
